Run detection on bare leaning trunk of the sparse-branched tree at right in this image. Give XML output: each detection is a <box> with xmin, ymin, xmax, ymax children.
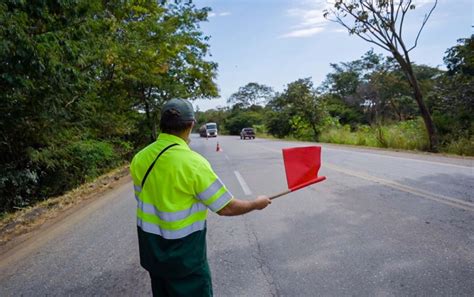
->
<box><xmin>392</xmin><ymin>51</ymin><xmax>438</xmax><ymax>152</ymax></box>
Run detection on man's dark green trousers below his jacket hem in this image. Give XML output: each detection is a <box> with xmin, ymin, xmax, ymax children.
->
<box><xmin>150</xmin><ymin>263</ymin><xmax>212</xmax><ymax>297</ymax></box>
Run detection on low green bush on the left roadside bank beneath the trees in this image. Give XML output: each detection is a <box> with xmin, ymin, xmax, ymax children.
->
<box><xmin>0</xmin><ymin>140</ymin><xmax>122</xmax><ymax>212</ymax></box>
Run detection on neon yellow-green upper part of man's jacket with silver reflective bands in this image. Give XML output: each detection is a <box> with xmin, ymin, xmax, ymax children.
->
<box><xmin>130</xmin><ymin>133</ymin><xmax>233</xmax><ymax>239</ymax></box>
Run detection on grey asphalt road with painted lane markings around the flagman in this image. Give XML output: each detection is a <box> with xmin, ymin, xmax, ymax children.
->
<box><xmin>0</xmin><ymin>135</ymin><xmax>474</xmax><ymax>296</ymax></box>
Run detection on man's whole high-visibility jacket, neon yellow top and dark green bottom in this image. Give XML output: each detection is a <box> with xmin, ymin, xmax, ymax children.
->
<box><xmin>130</xmin><ymin>133</ymin><xmax>233</xmax><ymax>276</ymax></box>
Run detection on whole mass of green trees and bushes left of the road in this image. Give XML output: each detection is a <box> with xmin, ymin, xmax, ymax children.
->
<box><xmin>0</xmin><ymin>0</ymin><xmax>218</xmax><ymax>211</ymax></box>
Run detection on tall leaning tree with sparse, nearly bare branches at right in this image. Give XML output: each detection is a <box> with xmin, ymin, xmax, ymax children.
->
<box><xmin>324</xmin><ymin>0</ymin><xmax>438</xmax><ymax>151</ymax></box>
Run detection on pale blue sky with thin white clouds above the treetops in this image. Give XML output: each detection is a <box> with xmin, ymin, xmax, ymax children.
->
<box><xmin>193</xmin><ymin>0</ymin><xmax>474</xmax><ymax>111</ymax></box>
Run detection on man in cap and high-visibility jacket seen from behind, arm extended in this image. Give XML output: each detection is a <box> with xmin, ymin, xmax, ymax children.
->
<box><xmin>130</xmin><ymin>99</ymin><xmax>271</xmax><ymax>297</ymax></box>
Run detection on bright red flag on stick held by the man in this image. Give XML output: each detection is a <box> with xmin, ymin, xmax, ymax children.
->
<box><xmin>283</xmin><ymin>146</ymin><xmax>326</xmax><ymax>192</ymax></box>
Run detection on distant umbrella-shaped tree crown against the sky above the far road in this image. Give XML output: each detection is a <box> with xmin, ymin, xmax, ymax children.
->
<box><xmin>227</xmin><ymin>82</ymin><xmax>273</xmax><ymax>107</ymax></box>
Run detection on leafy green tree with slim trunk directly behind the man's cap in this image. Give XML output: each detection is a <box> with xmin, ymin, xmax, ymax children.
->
<box><xmin>103</xmin><ymin>1</ymin><xmax>218</xmax><ymax>141</ymax></box>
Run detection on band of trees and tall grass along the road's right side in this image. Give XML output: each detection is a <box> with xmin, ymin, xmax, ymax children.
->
<box><xmin>198</xmin><ymin>37</ymin><xmax>474</xmax><ymax>156</ymax></box>
